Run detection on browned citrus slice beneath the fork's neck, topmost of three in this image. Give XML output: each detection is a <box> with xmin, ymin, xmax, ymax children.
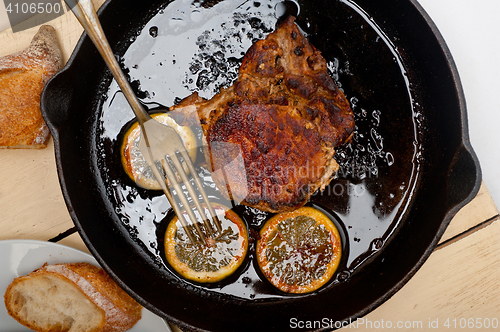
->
<box><xmin>121</xmin><ymin>113</ymin><xmax>196</xmax><ymax>190</ymax></box>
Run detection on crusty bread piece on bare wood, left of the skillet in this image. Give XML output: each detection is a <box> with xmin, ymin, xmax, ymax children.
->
<box><xmin>0</xmin><ymin>25</ymin><xmax>62</xmax><ymax>149</ymax></box>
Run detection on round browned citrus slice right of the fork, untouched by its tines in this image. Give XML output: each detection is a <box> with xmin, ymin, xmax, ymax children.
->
<box><xmin>256</xmin><ymin>207</ymin><xmax>342</xmax><ymax>293</ymax></box>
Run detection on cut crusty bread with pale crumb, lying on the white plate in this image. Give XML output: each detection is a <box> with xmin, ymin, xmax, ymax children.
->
<box><xmin>4</xmin><ymin>263</ymin><xmax>142</xmax><ymax>332</ymax></box>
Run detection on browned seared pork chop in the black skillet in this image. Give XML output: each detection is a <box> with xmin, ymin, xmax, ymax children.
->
<box><xmin>171</xmin><ymin>17</ymin><xmax>354</xmax><ymax>213</ymax></box>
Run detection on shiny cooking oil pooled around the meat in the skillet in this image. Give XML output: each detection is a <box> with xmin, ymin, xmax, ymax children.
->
<box><xmin>94</xmin><ymin>0</ymin><xmax>420</xmax><ymax>299</ymax></box>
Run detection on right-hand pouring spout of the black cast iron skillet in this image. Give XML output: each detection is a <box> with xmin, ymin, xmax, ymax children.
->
<box><xmin>446</xmin><ymin>144</ymin><xmax>482</xmax><ymax>214</ymax></box>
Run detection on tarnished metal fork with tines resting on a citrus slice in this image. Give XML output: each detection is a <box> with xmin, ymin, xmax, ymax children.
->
<box><xmin>65</xmin><ymin>0</ymin><xmax>222</xmax><ymax>243</ymax></box>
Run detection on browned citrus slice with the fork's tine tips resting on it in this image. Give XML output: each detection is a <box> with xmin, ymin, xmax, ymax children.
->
<box><xmin>165</xmin><ymin>204</ymin><xmax>248</xmax><ymax>283</ymax></box>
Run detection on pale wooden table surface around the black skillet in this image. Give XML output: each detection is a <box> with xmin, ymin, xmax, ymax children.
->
<box><xmin>0</xmin><ymin>0</ymin><xmax>500</xmax><ymax>331</ymax></box>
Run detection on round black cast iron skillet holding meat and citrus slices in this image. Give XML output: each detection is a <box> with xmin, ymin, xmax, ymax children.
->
<box><xmin>41</xmin><ymin>0</ymin><xmax>481</xmax><ymax>331</ymax></box>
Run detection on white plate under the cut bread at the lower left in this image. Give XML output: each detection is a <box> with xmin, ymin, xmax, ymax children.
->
<box><xmin>0</xmin><ymin>240</ymin><xmax>171</xmax><ymax>332</ymax></box>
